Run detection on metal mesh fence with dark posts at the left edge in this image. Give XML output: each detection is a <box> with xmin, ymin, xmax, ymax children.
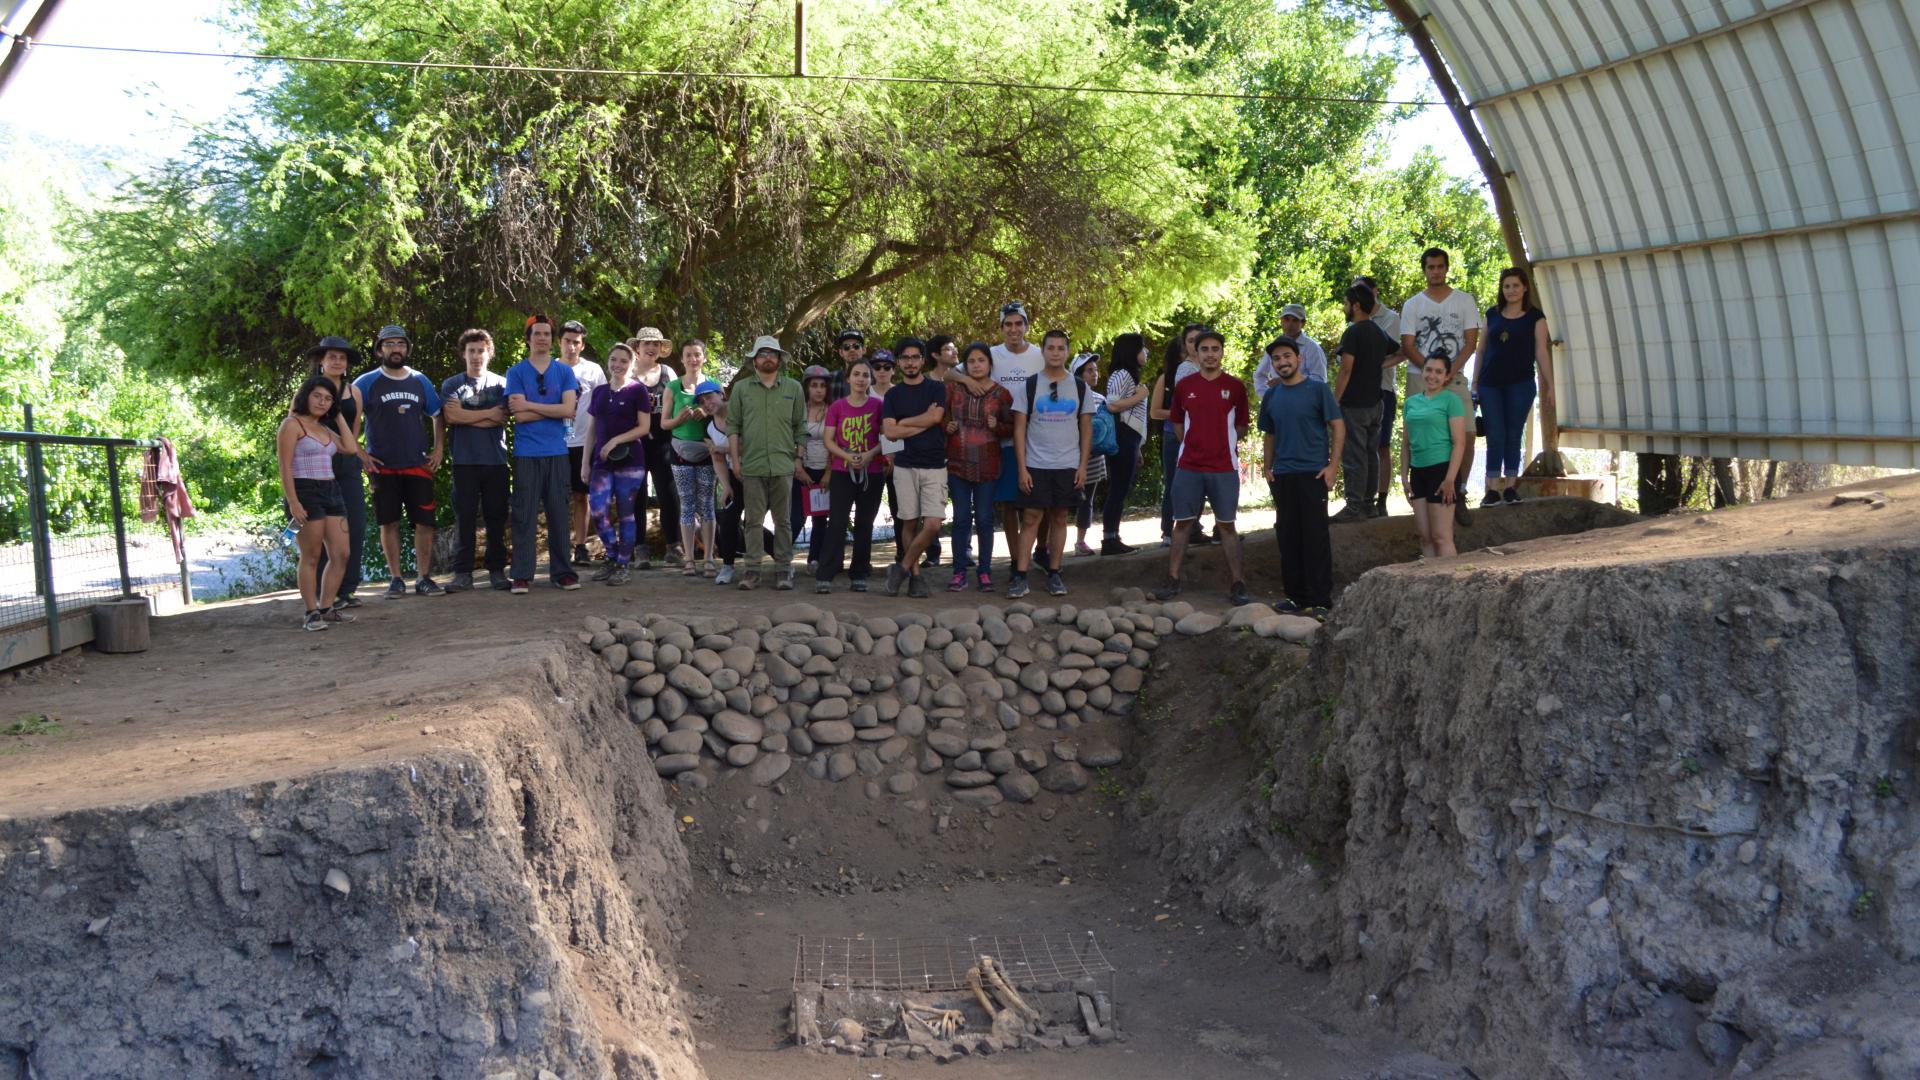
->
<box><xmin>0</xmin><ymin>407</ymin><xmax>192</xmax><ymax>669</ymax></box>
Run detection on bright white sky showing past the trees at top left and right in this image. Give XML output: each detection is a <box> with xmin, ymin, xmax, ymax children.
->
<box><xmin>0</xmin><ymin>0</ymin><xmax>1475</xmax><ymax>175</ymax></box>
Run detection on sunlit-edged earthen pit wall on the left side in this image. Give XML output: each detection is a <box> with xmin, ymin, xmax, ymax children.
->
<box><xmin>0</xmin><ymin>648</ymin><xmax>703</xmax><ymax>1080</ymax></box>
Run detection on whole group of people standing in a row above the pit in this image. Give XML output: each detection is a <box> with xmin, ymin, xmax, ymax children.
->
<box><xmin>278</xmin><ymin>250</ymin><xmax>1553</xmax><ymax>630</ymax></box>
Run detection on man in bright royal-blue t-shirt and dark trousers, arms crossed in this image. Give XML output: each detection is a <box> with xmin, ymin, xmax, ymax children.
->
<box><xmin>507</xmin><ymin>315</ymin><xmax>580</xmax><ymax>594</ymax></box>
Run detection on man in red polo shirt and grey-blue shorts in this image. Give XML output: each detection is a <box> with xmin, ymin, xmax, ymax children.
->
<box><xmin>1154</xmin><ymin>331</ymin><xmax>1252</xmax><ymax>605</ymax></box>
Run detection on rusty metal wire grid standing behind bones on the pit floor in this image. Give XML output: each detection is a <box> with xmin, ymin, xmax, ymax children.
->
<box><xmin>793</xmin><ymin>930</ymin><xmax>1114</xmax><ymax>994</ymax></box>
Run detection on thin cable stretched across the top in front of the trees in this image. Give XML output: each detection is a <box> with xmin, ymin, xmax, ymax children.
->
<box><xmin>0</xmin><ymin>31</ymin><xmax>1440</xmax><ymax>108</ymax></box>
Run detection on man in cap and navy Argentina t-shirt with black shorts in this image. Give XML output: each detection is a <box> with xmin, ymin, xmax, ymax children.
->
<box><xmin>353</xmin><ymin>325</ymin><xmax>447</xmax><ymax>600</ymax></box>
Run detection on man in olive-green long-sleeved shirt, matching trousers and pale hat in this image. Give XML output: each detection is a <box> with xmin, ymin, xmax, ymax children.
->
<box><xmin>726</xmin><ymin>334</ymin><xmax>806</xmax><ymax>590</ymax></box>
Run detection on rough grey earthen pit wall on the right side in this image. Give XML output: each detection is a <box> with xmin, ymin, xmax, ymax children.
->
<box><xmin>1140</xmin><ymin>550</ymin><xmax>1920</xmax><ymax>1078</ymax></box>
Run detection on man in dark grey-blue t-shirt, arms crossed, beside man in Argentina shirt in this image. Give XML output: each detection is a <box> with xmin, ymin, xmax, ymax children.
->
<box><xmin>440</xmin><ymin>331</ymin><xmax>507</xmax><ymax>592</ymax></box>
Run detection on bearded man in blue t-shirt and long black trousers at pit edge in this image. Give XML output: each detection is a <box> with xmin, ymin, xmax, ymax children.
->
<box><xmin>1260</xmin><ymin>338</ymin><xmax>1344</xmax><ymax>619</ymax></box>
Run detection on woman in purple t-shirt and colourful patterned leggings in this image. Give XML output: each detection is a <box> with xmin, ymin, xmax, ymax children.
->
<box><xmin>580</xmin><ymin>344</ymin><xmax>653</xmax><ymax>584</ymax></box>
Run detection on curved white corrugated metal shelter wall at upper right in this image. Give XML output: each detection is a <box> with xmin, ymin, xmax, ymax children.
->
<box><xmin>1409</xmin><ymin>0</ymin><xmax>1920</xmax><ymax>469</ymax></box>
